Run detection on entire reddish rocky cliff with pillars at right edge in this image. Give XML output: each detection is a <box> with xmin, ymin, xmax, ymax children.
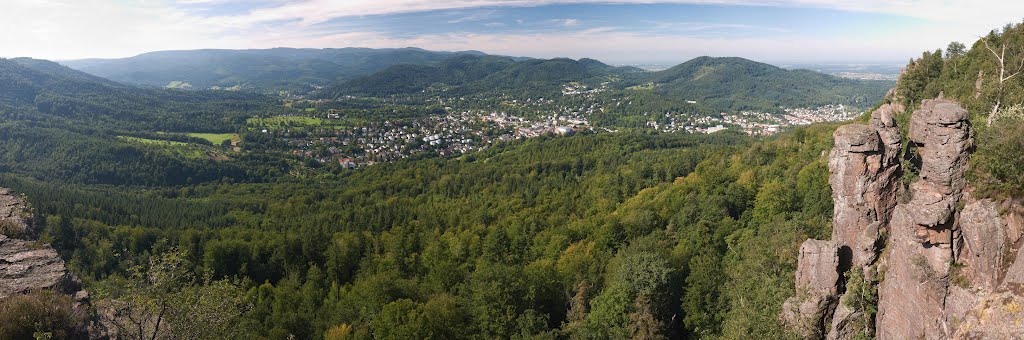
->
<box><xmin>781</xmin><ymin>99</ymin><xmax>1024</xmax><ymax>339</ymax></box>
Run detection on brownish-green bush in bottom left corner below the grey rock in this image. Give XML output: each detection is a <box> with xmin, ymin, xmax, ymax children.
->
<box><xmin>0</xmin><ymin>291</ymin><xmax>88</xmax><ymax>339</ymax></box>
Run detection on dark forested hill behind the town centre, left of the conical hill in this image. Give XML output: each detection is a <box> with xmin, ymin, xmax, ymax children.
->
<box><xmin>319</xmin><ymin>55</ymin><xmax>640</xmax><ymax>97</ymax></box>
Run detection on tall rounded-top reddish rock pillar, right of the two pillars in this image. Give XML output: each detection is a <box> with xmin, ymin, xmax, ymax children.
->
<box><xmin>878</xmin><ymin>99</ymin><xmax>973</xmax><ymax>339</ymax></box>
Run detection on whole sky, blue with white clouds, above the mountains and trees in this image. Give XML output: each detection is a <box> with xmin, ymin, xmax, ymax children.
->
<box><xmin>0</xmin><ymin>0</ymin><xmax>1024</xmax><ymax>65</ymax></box>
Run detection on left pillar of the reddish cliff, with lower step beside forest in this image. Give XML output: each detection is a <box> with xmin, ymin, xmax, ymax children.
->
<box><xmin>781</xmin><ymin>104</ymin><xmax>903</xmax><ymax>339</ymax></box>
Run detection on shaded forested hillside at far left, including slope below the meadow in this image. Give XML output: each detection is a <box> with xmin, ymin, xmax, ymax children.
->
<box><xmin>0</xmin><ymin>59</ymin><xmax>284</xmax><ymax>185</ymax></box>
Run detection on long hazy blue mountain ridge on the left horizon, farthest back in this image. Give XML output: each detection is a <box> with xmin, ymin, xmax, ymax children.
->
<box><xmin>61</xmin><ymin>48</ymin><xmax>483</xmax><ymax>92</ymax></box>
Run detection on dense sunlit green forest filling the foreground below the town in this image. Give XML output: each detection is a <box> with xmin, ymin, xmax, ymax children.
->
<box><xmin>0</xmin><ymin>126</ymin><xmax>831</xmax><ymax>339</ymax></box>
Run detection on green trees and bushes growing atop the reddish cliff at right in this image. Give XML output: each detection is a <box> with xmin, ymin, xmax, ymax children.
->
<box><xmin>896</xmin><ymin>20</ymin><xmax>1024</xmax><ymax>198</ymax></box>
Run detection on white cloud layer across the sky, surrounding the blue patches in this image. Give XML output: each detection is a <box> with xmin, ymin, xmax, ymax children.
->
<box><xmin>6</xmin><ymin>0</ymin><xmax>1024</xmax><ymax>61</ymax></box>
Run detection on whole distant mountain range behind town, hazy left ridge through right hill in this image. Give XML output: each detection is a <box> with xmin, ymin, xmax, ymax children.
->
<box><xmin>54</xmin><ymin>48</ymin><xmax>894</xmax><ymax>112</ymax></box>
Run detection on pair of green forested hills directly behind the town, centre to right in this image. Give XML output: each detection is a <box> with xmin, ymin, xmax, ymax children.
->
<box><xmin>315</xmin><ymin>55</ymin><xmax>893</xmax><ymax>112</ymax></box>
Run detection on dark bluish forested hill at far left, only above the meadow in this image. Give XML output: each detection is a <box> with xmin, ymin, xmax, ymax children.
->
<box><xmin>0</xmin><ymin>58</ymin><xmax>273</xmax><ymax>131</ymax></box>
